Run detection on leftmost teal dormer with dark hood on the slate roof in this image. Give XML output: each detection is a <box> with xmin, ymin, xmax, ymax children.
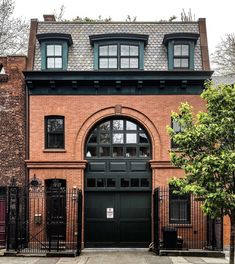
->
<box><xmin>37</xmin><ymin>33</ymin><xmax>73</xmax><ymax>70</ymax></box>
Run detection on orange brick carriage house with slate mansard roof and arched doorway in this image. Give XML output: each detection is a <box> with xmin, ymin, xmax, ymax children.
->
<box><xmin>21</xmin><ymin>16</ymin><xmax>221</xmax><ymax>254</ymax></box>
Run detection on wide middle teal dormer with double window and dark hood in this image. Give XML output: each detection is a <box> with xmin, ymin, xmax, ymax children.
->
<box><xmin>90</xmin><ymin>34</ymin><xmax>148</xmax><ymax>70</ymax></box>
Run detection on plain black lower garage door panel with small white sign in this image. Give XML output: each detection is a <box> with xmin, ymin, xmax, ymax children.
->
<box><xmin>85</xmin><ymin>192</ymin><xmax>151</xmax><ymax>247</ymax></box>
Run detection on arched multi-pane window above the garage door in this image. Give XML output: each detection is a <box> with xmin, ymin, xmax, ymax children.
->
<box><xmin>86</xmin><ymin>119</ymin><xmax>150</xmax><ymax>158</ymax></box>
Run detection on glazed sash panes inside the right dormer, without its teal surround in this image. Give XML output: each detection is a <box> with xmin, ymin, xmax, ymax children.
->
<box><xmin>173</xmin><ymin>44</ymin><xmax>189</xmax><ymax>69</ymax></box>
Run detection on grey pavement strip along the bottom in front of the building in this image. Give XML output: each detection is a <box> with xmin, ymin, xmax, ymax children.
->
<box><xmin>0</xmin><ymin>251</ymin><xmax>228</xmax><ymax>264</ymax></box>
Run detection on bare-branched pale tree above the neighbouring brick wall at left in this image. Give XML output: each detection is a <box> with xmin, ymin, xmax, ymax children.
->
<box><xmin>0</xmin><ymin>0</ymin><xmax>29</xmax><ymax>55</ymax></box>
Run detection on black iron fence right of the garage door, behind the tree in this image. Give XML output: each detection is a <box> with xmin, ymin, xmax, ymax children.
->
<box><xmin>154</xmin><ymin>187</ymin><xmax>222</xmax><ymax>253</ymax></box>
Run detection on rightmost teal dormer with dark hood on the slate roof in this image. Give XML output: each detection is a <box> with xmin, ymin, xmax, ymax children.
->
<box><xmin>163</xmin><ymin>33</ymin><xmax>199</xmax><ymax>70</ymax></box>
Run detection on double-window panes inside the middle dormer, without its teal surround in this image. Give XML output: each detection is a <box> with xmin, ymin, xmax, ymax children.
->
<box><xmin>99</xmin><ymin>43</ymin><xmax>139</xmax><ymax>69</ymax></box>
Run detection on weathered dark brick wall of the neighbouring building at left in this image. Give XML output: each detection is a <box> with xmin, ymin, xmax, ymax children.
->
<box><xmin>0</xmin><ymin>56</ymin><xmax>26</xmax><ymax>186</ymax></box>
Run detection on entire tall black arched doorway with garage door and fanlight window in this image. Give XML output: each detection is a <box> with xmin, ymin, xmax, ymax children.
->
<box><xmin>85</xmin><ymin>119</ymin><xmax>152</xmax><ymax>247</ymax></box>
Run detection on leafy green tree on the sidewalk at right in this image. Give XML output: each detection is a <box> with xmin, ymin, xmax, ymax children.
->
<box><xmin>168</xmin><ymin>82</ymin><xmax>235</xmax><ymax>264</ymax></box>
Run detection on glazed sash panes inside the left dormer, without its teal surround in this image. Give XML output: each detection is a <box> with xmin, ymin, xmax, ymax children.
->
<box><xmin>46</xmin><ymin>44</ymin><xmax>63</xmax><ymax>69</ymax></box>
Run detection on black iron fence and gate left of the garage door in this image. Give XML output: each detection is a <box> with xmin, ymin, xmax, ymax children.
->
<box><xmin>7</xmin><ymin>186</ymin><xmax>82</xmax><ymax>255</ymax></box>
